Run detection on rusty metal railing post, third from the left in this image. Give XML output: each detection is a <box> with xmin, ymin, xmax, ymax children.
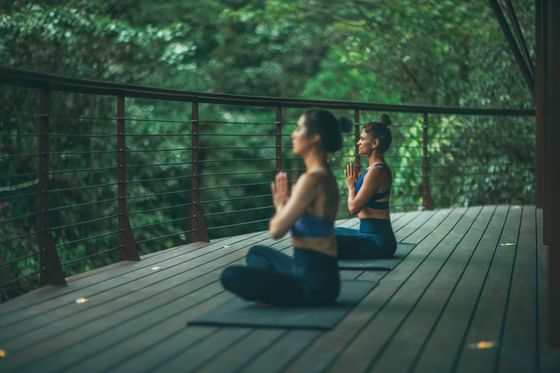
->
<box><xmin>190</xmin><ymin>101</ymin><xmax>210</xmax><ymax>242</ymax></box>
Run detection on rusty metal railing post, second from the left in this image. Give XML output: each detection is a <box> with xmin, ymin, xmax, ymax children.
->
<box><xmin>117</xmin><ymin>96</ymin><xmax>140</xmax><ymax>260</ymax></box>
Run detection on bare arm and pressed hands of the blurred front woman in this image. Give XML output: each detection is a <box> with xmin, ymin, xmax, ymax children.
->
<box><xmin>268</xmin><ymin>173</ymin><xmax>320</xmax><ymax>239</ymax></box>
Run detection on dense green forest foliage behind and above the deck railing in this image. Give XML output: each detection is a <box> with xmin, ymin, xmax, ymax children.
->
<box><xmin>0</xmin><ymin>0</ymin><xmax>534</xmax><ymax>299</ymax></box>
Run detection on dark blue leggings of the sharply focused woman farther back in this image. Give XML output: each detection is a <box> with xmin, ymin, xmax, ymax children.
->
<box><xmin>335</xmin><ymin>219</ymin><xmax>397</xmax><ymax>259</ymax></box>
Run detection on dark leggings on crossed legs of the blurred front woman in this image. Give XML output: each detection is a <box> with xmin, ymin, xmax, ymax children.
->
<box><xmin>221</xmin><ymin>246</ymin><xmax>340</xmax><ymax>306</ymax></box>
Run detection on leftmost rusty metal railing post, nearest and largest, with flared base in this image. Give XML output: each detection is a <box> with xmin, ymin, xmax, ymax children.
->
<box><xmin>37</xmin><ymin>88</ymin><xmax>66</xmax><ymax>286</ymax></box>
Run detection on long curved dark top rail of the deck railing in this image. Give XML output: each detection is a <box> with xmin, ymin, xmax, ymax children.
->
<box><xmin>0</xmin><ymin>67</ymin><xmax>535</xmax><ymax>116</ymax></box>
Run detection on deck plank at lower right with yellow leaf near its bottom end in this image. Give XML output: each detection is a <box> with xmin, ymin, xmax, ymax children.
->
<box><xmin>456</xmin><ymin>205</ymin><xmax>521</xmax><ymax>373</ymax></box>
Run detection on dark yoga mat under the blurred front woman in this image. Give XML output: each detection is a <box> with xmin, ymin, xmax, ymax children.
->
<box><xmin>188</xmin><ymin>280</ymin><xmax>377</xmax><ymax>330</ymax></box>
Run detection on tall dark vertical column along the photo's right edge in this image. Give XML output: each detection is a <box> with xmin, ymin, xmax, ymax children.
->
<box><xmin>540</xmin><ymin>0</ymin><xmax>560</xmax><ymax>349</ymax></box>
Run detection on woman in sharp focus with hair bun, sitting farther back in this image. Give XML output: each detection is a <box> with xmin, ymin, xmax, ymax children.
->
<box><xmin>336</xmin><ymin>114</ymin><xmax>397</xmax><ymax>259</ymax></box>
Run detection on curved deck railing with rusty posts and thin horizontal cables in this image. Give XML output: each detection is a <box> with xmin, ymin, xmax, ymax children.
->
<box><xmin>0</xmin><ymin>68</ymin><xmax>534</xmax><ymax>300</ymax></box>
